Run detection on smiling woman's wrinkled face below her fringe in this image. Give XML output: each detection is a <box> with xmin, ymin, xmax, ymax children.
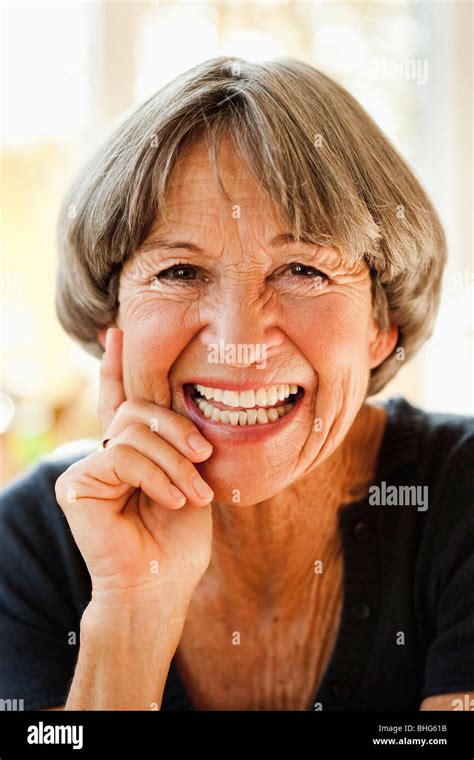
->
<box><xmin>117</xmin><ymin>140</ymin><xmax>396</xmax><ymax>505</ymax></box>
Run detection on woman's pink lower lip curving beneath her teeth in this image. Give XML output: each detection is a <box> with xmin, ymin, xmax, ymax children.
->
<box><xmin>183</xmin><ymin>385</ymin><xmax>304</xmax><ymax>443</ymax></box>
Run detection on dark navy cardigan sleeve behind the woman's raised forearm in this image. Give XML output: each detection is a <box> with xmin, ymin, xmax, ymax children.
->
<box><xmin>0</xmin><ymin>452</ymin><xmax>90</xmax><ymax>710</ymax></box>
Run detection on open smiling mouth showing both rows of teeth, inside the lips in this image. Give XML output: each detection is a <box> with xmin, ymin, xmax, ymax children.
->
<box><xmin>184</xmin><ymin>383</ymin><xmax>304</xmax><ymax>427</ymax></box>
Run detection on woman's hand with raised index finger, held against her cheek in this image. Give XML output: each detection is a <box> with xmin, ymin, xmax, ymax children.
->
<box><xmin>55</xmin><ymin>328</ymin><xmax>213</xmax><ymax>603</ymax></box>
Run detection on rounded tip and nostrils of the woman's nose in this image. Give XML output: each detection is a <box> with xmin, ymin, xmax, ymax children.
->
<box><xmin>200</xmin><ymin>292</ymin><xmax>284</xmax><ymax>367</ymax></box>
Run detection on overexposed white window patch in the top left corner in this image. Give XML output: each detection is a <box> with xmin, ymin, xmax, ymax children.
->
<box><xmin>2</xmin><ymin>2</ymin><xmax>90</xmax><ymax>145</ymax></box>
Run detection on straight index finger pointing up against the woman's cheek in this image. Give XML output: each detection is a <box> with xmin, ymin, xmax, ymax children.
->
<box><xmin>97</xmin><ymin>327</ymin><xmax>126</xmax><ymax>431</ymax></box>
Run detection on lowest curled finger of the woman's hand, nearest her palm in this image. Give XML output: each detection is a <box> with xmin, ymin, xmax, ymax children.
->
<box><xmin>56</xmin><ymin>443</ymin><xmax>186</xmax><ymax>519</ymax></box>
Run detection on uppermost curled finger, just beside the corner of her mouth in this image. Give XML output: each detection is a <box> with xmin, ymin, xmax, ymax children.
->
<box><xmin>104</xmin><ymin>399</ymin><xmax>212</xmax><ymax>462</ymax></box>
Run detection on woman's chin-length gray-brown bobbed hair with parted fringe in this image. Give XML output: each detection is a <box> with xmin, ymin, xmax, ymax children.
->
<box><xmin>56</xmin><ymin>57</ymin><xmax>446</xmax><ymax>395</ymax></box>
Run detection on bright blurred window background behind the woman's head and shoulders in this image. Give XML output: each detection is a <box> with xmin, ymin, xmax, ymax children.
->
<box><xmin>0</xmin><ymin>0</ymin><xmax>474</xmax><ymax>483</ymax></box>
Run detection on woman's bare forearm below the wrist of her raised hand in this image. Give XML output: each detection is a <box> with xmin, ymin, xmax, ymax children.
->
<box><xmin>65</xmin><ymin>600</ymin><xmax>191</xmax><ymax>710</ymax></box>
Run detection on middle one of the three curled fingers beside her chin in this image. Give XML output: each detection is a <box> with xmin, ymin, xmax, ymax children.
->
<box><xmin>106</xmin><ymin>423</ymin><xmax>214</xmax><ymax>506</ymax></box>
